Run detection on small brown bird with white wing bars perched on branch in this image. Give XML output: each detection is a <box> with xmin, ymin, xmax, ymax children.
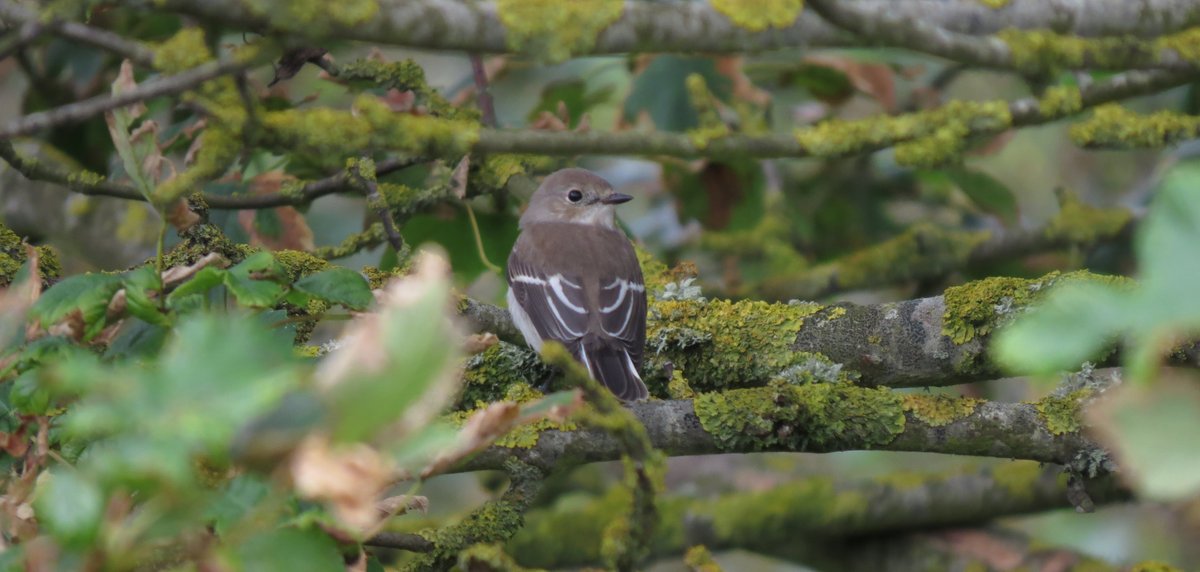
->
<box><xmin>506</xmin><ymin>168</ymin><xmax>649</xmax><ymax>403</ymax></box>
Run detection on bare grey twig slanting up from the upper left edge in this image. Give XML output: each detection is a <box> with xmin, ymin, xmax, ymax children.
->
<box><xmin>0</xmin><ymin>60</ymin><xmax>254</xmax><ymax>140</ymax></box>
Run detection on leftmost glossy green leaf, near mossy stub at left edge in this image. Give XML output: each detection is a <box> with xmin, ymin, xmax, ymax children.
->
<box><xmin>29</xmin><ymin>273</ymin><xmax>121</xmax><ymax>339</ymax></box>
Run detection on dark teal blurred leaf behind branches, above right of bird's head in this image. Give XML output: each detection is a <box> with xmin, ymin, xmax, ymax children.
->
<box><xmin>624</xmin><ymin>55</ymin><xmax>732</xmax><ymax>131</ymax></box>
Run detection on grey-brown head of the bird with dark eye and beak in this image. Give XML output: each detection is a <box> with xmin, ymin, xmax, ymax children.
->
<box><xmin>521</xmin><ymin>169</ymin><xmax>632</xmax><ymax>228</ymax></box>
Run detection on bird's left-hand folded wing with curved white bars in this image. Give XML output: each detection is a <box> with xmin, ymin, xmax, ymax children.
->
<box><xmin>508</xmin><ymin>249</ymin><xmax>588</xmax><ymax>343</ymax></box>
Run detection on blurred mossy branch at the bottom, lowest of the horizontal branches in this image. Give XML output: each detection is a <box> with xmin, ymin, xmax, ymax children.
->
<box><xmin>508</xmin><ymin>462</ymin><xmax>1128</xmax><ymax>570</ymax></box>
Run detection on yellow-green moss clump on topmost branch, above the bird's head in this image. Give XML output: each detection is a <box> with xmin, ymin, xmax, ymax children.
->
<box><xmin>496</xmin><ymin>0</ymin><xmax>625</xmax><ymax>62</ymax></box>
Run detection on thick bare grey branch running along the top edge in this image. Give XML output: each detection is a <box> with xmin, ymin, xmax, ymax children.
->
<box><xmin>124</xmin><ymin>0</ymin><xmax>1200</xmax><ymax>55</ymax></box>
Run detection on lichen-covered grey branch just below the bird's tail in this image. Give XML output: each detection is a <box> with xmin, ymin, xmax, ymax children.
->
<box><xmin>457</xmin><ymin>384</ymin><xmax>1108</xmax><ymax>471</ymax></box>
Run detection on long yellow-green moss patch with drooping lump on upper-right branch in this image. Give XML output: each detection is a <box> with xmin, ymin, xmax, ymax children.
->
<box><xmin>796</xmin><ymin>100</ymin><xmax>1013</xmax><ymax>167</ymax></box>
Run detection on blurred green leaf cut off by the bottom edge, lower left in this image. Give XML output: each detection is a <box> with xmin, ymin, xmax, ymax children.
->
<box><xmin>236</xmin><ymin>528</ymin><xmax>346</xmax><ymax>572</ymax></box>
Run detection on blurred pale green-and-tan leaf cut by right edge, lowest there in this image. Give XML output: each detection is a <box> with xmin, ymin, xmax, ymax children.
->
<box><xmin>1085</xmin><ymin>372</ymin><xmax>1200</xmax><ymax>501</ymax></box>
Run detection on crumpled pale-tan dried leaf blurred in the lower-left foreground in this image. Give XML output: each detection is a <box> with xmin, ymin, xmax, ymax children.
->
<box><xmin>289</xmin><ymin>435</ymin><xmax>392</xmax><ymax>531</ymax></box>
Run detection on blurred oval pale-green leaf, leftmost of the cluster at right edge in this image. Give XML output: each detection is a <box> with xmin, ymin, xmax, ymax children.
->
<box><xmin>992</xmin><ymin>282</ymin><xmax>1124</xmax><ymax>374</ymax></box>
